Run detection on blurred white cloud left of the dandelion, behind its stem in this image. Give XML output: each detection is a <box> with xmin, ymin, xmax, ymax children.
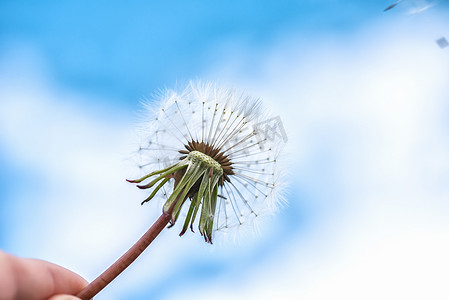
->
<box><xmin>0</xmin><ymin>48</ymin><xmax>208</xmax><ymax>299</ymax></box>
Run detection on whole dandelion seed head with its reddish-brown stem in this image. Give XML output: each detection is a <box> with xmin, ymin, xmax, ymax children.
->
<box><xmin>78</xmin><ymin>82</ymin><xmax>286</xmax><ymax>299</ymax></box>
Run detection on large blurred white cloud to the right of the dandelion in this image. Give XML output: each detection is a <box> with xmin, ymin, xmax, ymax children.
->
<box><xmin>190</xmin><ymin>10</ymin><xmax>449</xmax><ymax>300</ymax></box>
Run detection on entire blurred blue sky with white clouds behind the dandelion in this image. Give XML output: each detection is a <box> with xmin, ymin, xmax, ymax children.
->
<box><xmin>0</xmin><ymin>0</ymin><xmax>449</xmax><ymax>300</ymax></box>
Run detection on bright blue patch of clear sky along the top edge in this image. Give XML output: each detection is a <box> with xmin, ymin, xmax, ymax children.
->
<box><xmin>0</xmin><ymin>1</ymin><xmax>384</xmax><ymax>106</ymax></box>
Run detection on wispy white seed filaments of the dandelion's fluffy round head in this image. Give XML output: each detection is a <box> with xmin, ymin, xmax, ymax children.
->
<box><xmin>135</xmin><ymin>82</ymin><xmax>284</xmax><ymax>238</ymax></box>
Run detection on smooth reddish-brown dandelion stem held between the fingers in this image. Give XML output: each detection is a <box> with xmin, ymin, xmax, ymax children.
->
<box><xmin>76</xmin><ymin>212</ymin><xmax>171</xmax><ymax>300</ymax></box>
